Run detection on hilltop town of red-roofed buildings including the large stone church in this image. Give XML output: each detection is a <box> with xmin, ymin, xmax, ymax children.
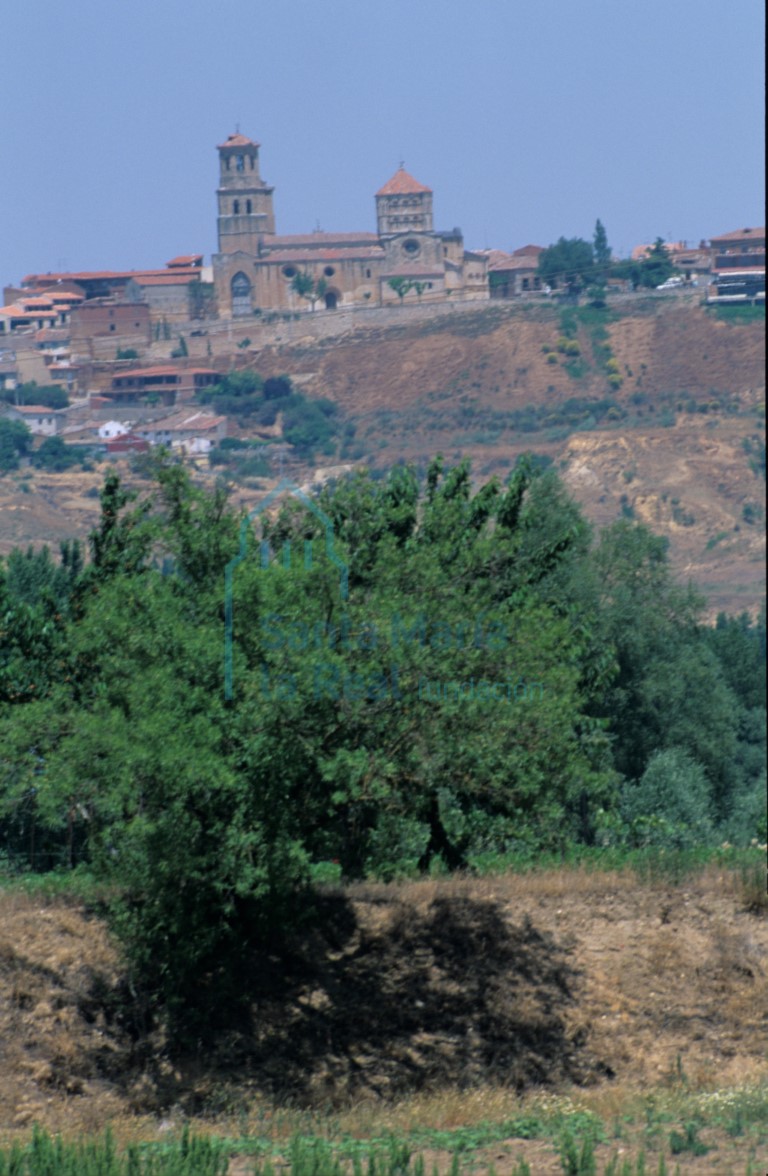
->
<box><xmin>0</xmin><ymin>133</ymin><xmax>766</xmax><ymax>455</ymax></box>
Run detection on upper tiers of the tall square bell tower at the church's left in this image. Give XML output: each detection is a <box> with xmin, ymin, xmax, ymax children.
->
<box><xmin>216</xmin><ymin>132</ymin><xmax>275</xmax><ymax>255</ymax></box>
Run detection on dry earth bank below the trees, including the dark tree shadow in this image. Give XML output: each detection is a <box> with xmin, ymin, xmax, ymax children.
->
<box><xmin>0</xmin><ymin>871</ymin><xmax>768</xmax><ymax>1132</ymax></box>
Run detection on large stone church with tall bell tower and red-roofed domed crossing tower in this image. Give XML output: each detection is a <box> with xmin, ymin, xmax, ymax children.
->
<box><xmin>213</xmin><ymin>133</ymin><xmax>488</xmax><ymax>318</ymax></box>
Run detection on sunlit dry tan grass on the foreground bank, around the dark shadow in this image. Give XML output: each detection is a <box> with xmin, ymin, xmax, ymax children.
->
<box><xmin>0</xmin><ymin>867</ymin><xmax>768</xmax><ymax>1176</ymax></box>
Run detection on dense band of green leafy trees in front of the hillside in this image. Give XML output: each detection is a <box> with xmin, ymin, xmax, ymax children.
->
<box><xmin>0</xmin><ymin>456</ymin><xmax>764</xmax><ymax>1037</ymax></box>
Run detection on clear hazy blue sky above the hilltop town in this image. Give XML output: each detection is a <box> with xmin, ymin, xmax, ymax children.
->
<box><xmin>0</xmin><ymin>0</ymin><xmax>764</xmax><ymax>283</ymax></box>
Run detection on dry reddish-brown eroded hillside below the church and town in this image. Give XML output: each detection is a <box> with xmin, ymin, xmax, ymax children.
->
<box><xmin>0</xmin><ymin>295</ymin><xmax>764</xmax><ymax>613</ymax></box>
